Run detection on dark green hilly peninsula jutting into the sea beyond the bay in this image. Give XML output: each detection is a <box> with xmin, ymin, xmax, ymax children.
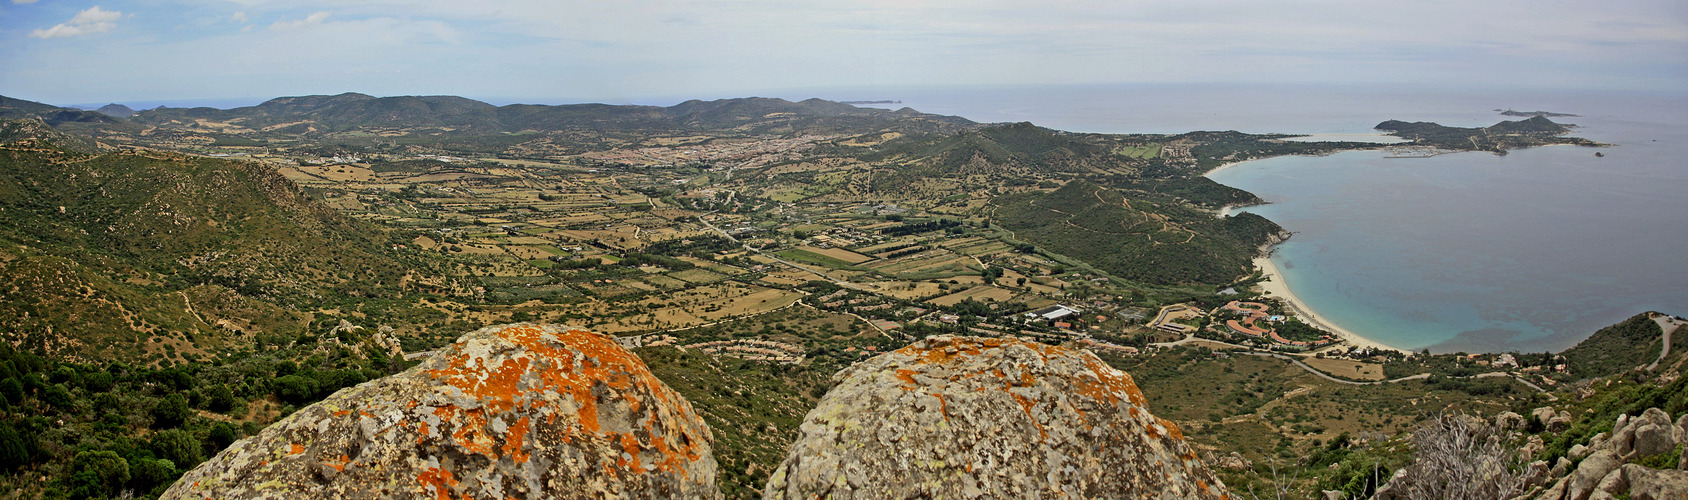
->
<box><xmin>1372</xmin><ymin>117</ymin><xmax>1605</xmax><ymax>154</ymax></box>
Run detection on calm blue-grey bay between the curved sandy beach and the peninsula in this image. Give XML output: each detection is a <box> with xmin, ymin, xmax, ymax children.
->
<box><xmin>1209</xmin><ymin>100</ymin><xmax>1688</xmax><ymax>351</ymax></box>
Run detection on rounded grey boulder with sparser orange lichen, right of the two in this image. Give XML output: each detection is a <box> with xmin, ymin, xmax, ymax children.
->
<box><xmin>763</xmin><ymin>336</ymin><xmax>1229</xmax><ymax>498</ymax></box>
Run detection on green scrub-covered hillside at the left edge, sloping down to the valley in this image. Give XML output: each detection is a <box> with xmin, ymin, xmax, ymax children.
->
<box><xmin>0</xmin><ymin>142</ymin><xmax>435</xmax><ymax>361</ymax></box>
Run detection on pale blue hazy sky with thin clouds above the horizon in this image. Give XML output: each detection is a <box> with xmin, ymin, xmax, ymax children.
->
<box><xmin>0</xmin><ymin>0</ymin><xmax>1688</xmax><ymax>105</ymax></box>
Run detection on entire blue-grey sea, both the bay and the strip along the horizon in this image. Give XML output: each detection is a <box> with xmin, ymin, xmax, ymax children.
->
<box><xmin>840</xmin><ymin>84</ymin><xmax>1688</xmax><ymax>351</ymax></box>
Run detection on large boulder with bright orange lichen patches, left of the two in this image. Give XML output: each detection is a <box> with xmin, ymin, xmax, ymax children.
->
<box><xmin>164</xmin><ymin>324</ymin><xmax>719</xmax><ymax>498</ymax></box>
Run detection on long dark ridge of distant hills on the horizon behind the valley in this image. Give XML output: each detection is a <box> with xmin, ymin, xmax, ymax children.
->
<box><xmin>133</xmin><ymin>93</ymin><xmax>974</xmax><ymax>135</ymax></box>
